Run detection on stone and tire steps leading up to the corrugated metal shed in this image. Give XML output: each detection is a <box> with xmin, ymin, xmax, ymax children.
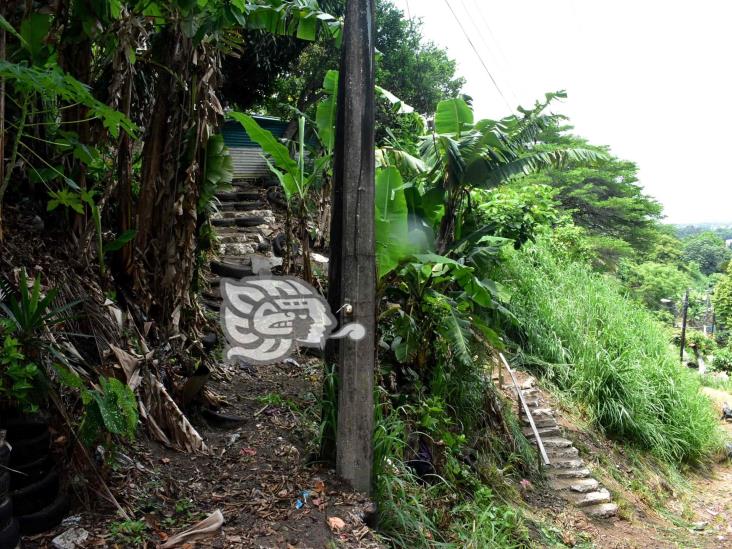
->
<box><xmin>202</xmin><ymin>180</ymin><xmax>282</xmax><ymax>311</ymax></box>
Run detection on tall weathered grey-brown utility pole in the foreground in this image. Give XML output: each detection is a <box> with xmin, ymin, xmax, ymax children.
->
<box><xmin>328</xmin><ymin>0</ymin><xmax>376</xmax><ymax>493</ymax></box>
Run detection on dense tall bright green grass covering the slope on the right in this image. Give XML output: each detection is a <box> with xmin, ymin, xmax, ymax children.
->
<box><xmin>499</xmin><ymin>242</ymin><xmax>719</xmax><ymax>463</ymax></box>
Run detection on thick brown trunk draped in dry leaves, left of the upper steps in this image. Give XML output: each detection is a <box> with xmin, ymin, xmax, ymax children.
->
<box><xmin>133</xmin><ymin>26</ymin><xmax>221</xmax><ymax>335</ymax></box>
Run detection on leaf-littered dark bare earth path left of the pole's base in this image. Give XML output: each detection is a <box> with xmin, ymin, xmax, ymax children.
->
<box><xmin>28</xmin><ymin>363</ymin><xmax>380</xmax><ymax>548</ymax></box>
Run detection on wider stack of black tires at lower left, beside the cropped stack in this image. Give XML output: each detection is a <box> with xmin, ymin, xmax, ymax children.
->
<box><xmin>0</xmin><ymin>417</ymin><xmax>69</xmax><ymax>548</ymax></box>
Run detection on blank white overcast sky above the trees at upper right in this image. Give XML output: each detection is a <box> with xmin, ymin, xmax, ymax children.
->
<box><xmin>393</xmin><ymin>0</ymin><xmax>732</xmax><ymax>223</ymax></box>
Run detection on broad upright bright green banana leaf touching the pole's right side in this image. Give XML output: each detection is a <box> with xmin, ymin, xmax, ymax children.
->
<box><xmin>375</xmin><ymin>167</ymin><xmax>410</xmax><ymax>278</ymax></box>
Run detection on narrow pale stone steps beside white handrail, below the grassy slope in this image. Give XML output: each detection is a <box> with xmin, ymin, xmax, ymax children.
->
<box><xmin>504</xmin><ymin>378</ymin><xmax>618</xmax><ymax>518</ymax></box>
